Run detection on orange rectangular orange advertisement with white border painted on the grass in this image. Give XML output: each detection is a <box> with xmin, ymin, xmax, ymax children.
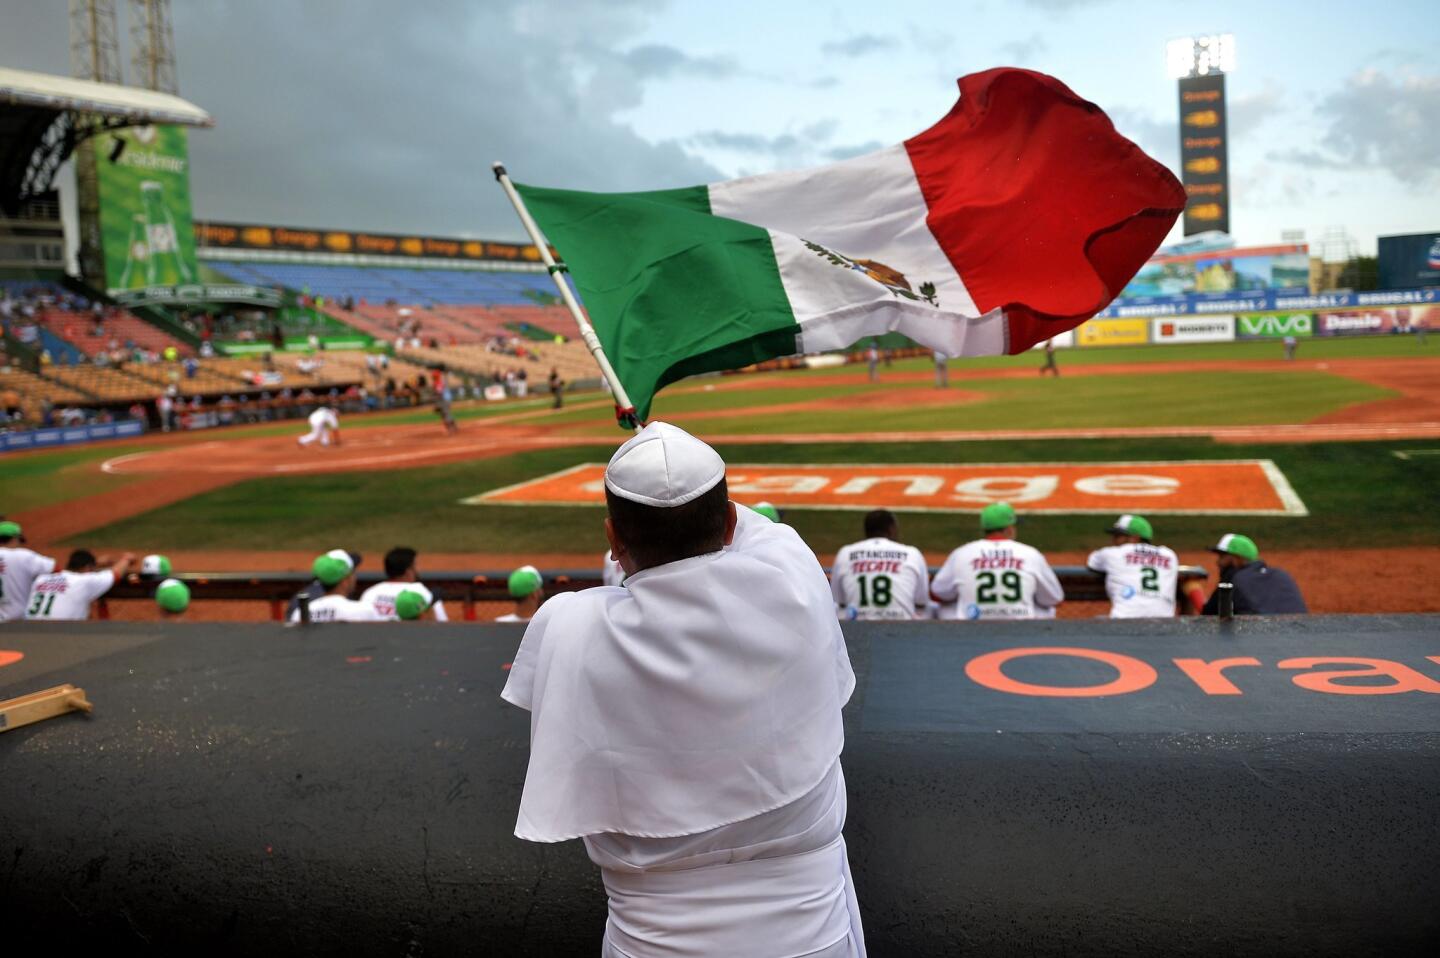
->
<box><xmin>461</xmin><ymin>460</ymin><xmax>1309</xmax><ymax>516</ymax></box>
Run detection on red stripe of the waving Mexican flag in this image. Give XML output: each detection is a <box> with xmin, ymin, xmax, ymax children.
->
<box><xmin>904</xmin><ymin>68</ymin><xmax>1185</xmax><ymax>353</ymax></box>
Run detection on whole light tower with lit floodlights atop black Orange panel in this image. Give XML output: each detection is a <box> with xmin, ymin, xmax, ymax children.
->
<box><xmin>1165</xmin><ymin>33</ymin><xmax>1236</xmax><ymax>236</ymax></box>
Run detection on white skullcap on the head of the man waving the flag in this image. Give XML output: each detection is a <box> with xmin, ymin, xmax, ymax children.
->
<box><xmin>605</xmin><ymin>422</ymin><xmax>724</xmax><ymax>509</ymax></box>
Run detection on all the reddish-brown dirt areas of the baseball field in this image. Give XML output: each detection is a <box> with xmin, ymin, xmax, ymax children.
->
<box><xmin>14</xmin><ymin>359</ymin><xmax>1440</xmax><ymax>617</ymax></box>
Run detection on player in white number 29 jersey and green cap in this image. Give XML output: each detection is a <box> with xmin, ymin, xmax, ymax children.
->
<box><xmin>930</xmin><ymin>503</ymin><xmax>1066</xmax><ymax>619</ymax></box>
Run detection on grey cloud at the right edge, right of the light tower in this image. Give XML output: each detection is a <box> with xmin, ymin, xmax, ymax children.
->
<box><xmin>1269</xmin><ymin>69</ymin><xmax>1440</xmax><ymax>187</ymax></box>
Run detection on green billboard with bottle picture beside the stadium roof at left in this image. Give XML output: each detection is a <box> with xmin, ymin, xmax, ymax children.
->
<box><xmin>94</xmin><ymin>127</ymin><xmax>197</xmax><ymax>295</ymax></box>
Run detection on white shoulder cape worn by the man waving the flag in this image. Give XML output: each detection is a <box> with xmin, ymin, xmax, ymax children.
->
<box><xmin>501</xmin><ymin>507</ymin><xmax>855</xmax><ymax>841</ymax></box>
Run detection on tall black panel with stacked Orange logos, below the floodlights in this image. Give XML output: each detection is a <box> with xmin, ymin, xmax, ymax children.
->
<box><xmin>1179</xmin><ymin>73</ymin><xmax>1230</xmax><ymax>236</ymax></box>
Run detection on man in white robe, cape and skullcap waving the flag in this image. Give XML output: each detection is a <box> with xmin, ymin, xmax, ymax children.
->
<box><xmin>501</xmin><ymin>422</ymin><xmax>864</xmax><ymax>958</ymax></box>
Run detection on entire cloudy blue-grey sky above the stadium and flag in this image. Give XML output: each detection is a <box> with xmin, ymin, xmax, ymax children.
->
<box><xmin>0</xmin><ymin>0</ymin><xmax>1440</xmax><ymax>252</ymax></box>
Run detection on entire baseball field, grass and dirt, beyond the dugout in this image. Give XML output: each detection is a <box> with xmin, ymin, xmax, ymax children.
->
<box><xmin>0</xmin><ymin>337</ymin><xmax>1440</xmax><ymax>614</ymax></box>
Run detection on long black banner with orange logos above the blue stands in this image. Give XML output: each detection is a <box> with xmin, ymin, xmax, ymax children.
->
<box><xmin>194</xmin><ymin>220</ymin><xmax>540</xmax><ymax>262</ymax></box>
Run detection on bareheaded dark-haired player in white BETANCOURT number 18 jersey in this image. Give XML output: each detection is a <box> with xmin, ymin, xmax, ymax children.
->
<box><xmin>829</xmin><ymin>509</ymin><xmax>930</xmax><ymax>621</ymax></box>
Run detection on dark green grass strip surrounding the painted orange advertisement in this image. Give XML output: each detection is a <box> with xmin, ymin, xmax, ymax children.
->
<box><xmin>64</xmin><ymin>439</ymin><xmax>1440</xmax><ymax>560</ymax></box>
